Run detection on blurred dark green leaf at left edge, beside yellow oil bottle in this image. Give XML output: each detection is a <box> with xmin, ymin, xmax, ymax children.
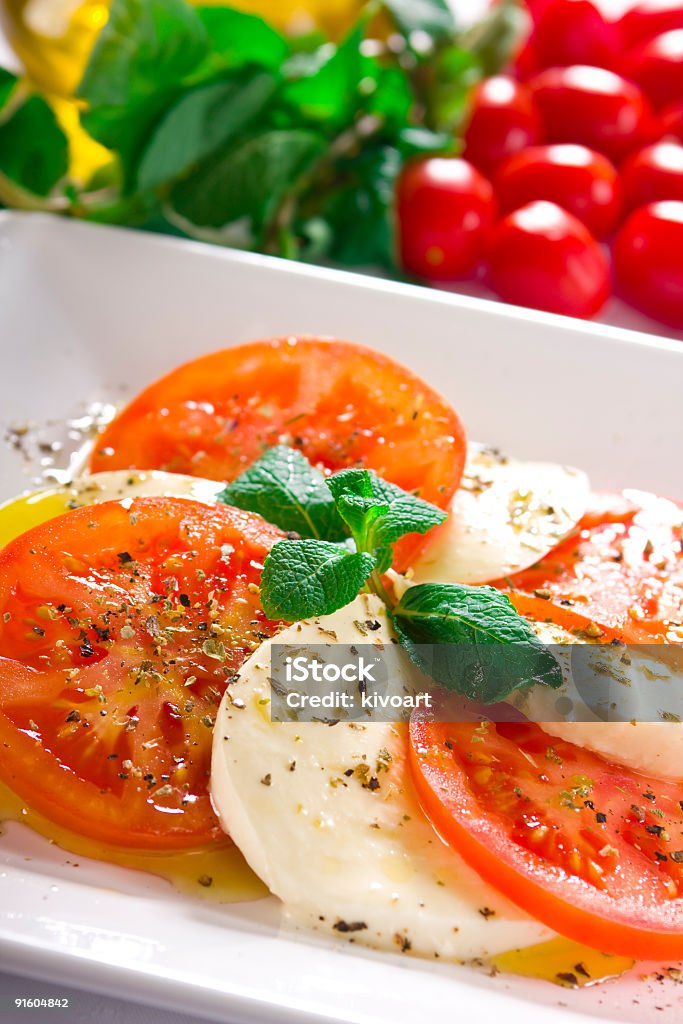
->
<box><xmin>0</xmin><ymin>96</ymin><xmax>69</xmax><ymax>196</ymax></box>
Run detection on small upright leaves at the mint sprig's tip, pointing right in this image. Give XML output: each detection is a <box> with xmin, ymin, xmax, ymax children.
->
<box><xmin>327</xmin><ymin>469</ymin><xmax>447</xmax><ymax>550</ymax></box>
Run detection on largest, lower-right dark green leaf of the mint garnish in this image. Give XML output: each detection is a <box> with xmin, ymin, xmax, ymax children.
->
<box><xmin>393</xmin><ymin>584</ymin><xmax>562</xmax><ymax>703</ymax></box>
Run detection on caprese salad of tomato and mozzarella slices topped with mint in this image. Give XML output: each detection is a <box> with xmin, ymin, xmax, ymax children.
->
<box><xmin>0</xmin><ymin>337</ymin><xmax>683</xmax><ymax>983</ymax></box>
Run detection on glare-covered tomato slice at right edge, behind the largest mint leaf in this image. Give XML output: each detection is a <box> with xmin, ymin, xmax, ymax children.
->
<box><xmin>498</xmin><ymin>490</ymin><xmax>683</xmax><ymax>643</ymax></box>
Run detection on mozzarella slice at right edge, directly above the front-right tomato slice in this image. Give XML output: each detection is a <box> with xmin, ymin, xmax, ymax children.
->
<box><xmin>512</xmin><ymin>623</ymin><xmax>683</xmax><ymax>780</ymax></box>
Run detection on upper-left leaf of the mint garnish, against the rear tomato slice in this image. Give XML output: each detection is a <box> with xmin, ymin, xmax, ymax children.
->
<box><xmin>218</xmin><ymin>444</ymin><xmax>348</xmax><ymax>544</ymax></box>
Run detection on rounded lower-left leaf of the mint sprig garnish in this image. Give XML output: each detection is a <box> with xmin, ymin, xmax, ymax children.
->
<box><xmin>261</xmin><ymin>541</ymin><xmax>375</xmax><ymax>623</ymax></box>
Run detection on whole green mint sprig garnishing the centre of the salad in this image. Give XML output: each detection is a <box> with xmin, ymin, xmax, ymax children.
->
<box><xmin>221</xmin><ymin>445</ymin><xmax>562</xmax><ymax>703</ymax></box>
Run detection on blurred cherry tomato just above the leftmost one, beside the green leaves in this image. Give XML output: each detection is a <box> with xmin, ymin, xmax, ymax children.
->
<box><xmin>465</xmin><ymin>75</ymin><xmax>541</xmax><ymax>174</ymax></box>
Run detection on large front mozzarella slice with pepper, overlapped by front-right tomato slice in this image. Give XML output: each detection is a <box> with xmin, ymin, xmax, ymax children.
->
<box><xmin>211</xmin><ymin>595</ymin><xmax>551</xmax><ymax>959</ymax></box>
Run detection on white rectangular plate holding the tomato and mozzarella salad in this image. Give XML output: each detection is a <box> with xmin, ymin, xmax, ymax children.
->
<box><xmin>0</xmin><ymin>213</ymin><xmax>683</xmax><ymax>1024</ymax></box>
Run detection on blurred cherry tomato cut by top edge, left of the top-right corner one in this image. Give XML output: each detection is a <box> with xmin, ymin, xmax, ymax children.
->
<box><xmin>533</xmin><ymin>0</ymin><xmax>620</xmax><ymax>68</ymax></box>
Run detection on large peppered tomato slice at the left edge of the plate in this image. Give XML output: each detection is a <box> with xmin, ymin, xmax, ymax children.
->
<box><xmin>0</xmin><ymin>498</ymin><xmax>283</xmax><ymax>850</ymax></box>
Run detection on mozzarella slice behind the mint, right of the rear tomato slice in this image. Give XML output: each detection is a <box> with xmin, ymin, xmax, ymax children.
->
<box><xmin>415</xmin><ymin>444</ymin><xmax>590</xmax><ymax>584</ymax></box>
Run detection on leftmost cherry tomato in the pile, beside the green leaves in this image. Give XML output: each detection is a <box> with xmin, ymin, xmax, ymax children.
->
<box><xmin>396</xmin><ymin>157</ymin><xmax>496</xmax><ymax>281</ymax></box>
